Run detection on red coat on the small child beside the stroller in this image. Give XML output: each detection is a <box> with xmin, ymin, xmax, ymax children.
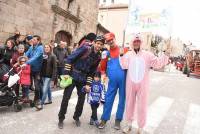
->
<box><xmin>18</xmin><ymin>65</ymin><xmax>31</xmax><ymax>86</ymax></box>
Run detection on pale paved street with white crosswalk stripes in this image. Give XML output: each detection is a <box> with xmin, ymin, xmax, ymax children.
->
<box><xmin>0</xmin><ymin>64</ymin><xmax>200</xmax><ymax>134</ymax></box>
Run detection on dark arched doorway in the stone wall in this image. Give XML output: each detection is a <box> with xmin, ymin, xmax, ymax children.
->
<box><xmin>55</xmin><ymin>30</ymin><xmax>72</xmax><ymax>45</ymax></box>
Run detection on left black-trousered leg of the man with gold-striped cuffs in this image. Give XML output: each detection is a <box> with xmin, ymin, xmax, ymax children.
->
<box><xmin>58</xmin><ymin>82</ymin><xmax>75</xmax><ymax>121</ymax></box>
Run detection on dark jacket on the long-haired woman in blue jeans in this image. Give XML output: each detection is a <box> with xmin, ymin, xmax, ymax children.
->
<box><xmin>41</xmin><ymin>54</ymin><xmax>57</xmax><ymax>79</ymax></box>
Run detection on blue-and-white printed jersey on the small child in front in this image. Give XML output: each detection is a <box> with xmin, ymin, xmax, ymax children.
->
<box><xmin>82</xmin><ymin>81</ymin><xmax>105</xmax><ymax>105</ymax></box>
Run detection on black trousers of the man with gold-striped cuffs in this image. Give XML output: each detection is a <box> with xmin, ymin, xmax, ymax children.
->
<box><xmin>58</xmin><ymin>80</ymin><xmax>85</xmax><ymax>121</ymax></box>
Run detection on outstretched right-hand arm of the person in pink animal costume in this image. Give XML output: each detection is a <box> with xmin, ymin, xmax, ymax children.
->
<box><xmin>150</xmin><ymin>53</ymin><xmax>169</xmax><ymax>69</ymax></box>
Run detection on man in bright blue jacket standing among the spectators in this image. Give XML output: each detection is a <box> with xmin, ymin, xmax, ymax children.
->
<box><xmin>26</xmin><ymin>35</ymin><xmax>43</xmax><ymax>108</ymax></box>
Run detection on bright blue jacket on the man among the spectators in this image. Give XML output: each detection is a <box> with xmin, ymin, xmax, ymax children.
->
<box><xmin>26</xmin><ymin>44</ymin><xmax>43</xmax><ymax>72</ymax></box>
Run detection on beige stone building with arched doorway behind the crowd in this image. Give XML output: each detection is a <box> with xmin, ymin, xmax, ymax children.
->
<box><xmin>0</xmin><ymin>0</ymin><xmax>98</xmax><ymax>44</ymax></box>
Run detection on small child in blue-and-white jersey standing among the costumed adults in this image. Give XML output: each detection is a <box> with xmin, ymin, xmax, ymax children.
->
<box><xmin>83</xmin><ymin>72</ymin><xmax>105</xmax><ymax>127</ymax></box>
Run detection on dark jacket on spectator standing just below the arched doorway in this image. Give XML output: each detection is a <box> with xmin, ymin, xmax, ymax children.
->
<box><xmin>53</xmin><ymin>46</ymin><xmax>68</xmax><ymax>67</ymax></box>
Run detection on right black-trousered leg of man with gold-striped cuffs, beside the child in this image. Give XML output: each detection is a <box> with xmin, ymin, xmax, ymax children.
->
<box><xmin>73</xmin><ymin>82</ymin><xmax>85</xmax><ymax>120</ymax></box>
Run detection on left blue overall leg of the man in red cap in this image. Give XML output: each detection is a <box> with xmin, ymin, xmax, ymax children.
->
<box><xmin>101</xmin><ymin>81</ymin><xmax>117</xmax><ymax>121</ymax></box>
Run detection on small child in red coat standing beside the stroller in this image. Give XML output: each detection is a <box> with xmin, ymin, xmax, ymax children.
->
<box><xmin>17</xmin><ymin>56</ymin><xmax>31</xmax><ymax>101</ymax></box>
